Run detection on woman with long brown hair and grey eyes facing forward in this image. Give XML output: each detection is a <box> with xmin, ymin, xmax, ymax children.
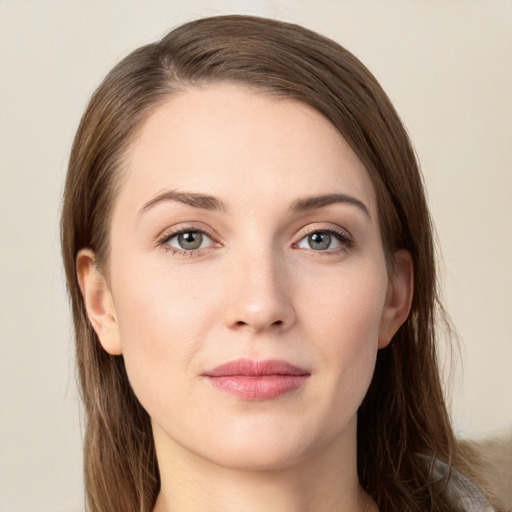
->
<box><xmin>62</xmin><ymin>16</ymin><xmax>496</xmax><ymax>512</ymax></box>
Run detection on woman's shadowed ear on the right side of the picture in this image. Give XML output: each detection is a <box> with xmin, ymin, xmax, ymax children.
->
<box><xmin>379</xmin><ymin>250</ymin><xmax>414</xmax><ymax>348</ymax></box>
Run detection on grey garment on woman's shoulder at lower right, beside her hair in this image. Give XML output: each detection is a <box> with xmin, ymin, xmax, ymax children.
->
<box><xmin>433</xmin><ymin>461</ymin><xmax>496</xmax><ymax>512</ymax></box>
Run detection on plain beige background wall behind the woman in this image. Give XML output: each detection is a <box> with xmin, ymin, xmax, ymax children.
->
<box><xmin>0</xmin><ymin>0</ymin><xmax>512</xmax><ymax>512</ymax></box>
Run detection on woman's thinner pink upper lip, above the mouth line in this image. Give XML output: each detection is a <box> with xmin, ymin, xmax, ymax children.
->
<box><xmin>204</xmin><ymin>359</ymin><xmax>310</xmax><ymax>377</ymax></box>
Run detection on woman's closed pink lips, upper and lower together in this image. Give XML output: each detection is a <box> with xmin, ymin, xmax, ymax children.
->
<box><xmin>203</xmin><ymin>359</ymin><xmax>311</xmax><ymax>400</ymax></box>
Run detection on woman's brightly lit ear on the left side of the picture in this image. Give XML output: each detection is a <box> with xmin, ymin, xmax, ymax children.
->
<box><xmin>76</xmin><ymin>249</ymin><xmax>122</xmax><ymax>355</ymax></box>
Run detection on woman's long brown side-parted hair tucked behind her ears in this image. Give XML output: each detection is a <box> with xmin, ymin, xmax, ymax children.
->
<box><xmin>61</xmin><ymin>16</ymin><xmax>472</xmax><ymax>512</ymax></box>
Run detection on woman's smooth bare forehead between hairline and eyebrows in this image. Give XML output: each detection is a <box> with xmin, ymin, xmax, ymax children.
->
<box><xmin>116</xmin><ymin>84</ymin><xmax>376</xmax><ymax>218</ymax></box>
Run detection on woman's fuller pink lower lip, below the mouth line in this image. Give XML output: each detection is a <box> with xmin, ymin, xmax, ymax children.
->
<box><xmin>208</xmin><ymin>375</ymin><xmax>309</xmax><ymax>400</ymax></box>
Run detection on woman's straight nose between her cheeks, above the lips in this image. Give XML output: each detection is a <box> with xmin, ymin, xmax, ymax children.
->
<box><xmin>224</xmin><ymin>250</ymin><xmax>295</xmax><ymax>333</ymax></box>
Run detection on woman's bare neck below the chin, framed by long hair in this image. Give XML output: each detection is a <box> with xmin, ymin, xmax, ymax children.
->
<box><xmin>153</xmin><ymin>420</ymin><xmax>377</xmax><ymax>512</ymax></box>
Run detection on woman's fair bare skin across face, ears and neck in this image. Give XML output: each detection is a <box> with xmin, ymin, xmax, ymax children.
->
<box><xmin>77</xmin><ymin>84</ymin><xmax>412</xmax><ymax>512</ymax></box>
